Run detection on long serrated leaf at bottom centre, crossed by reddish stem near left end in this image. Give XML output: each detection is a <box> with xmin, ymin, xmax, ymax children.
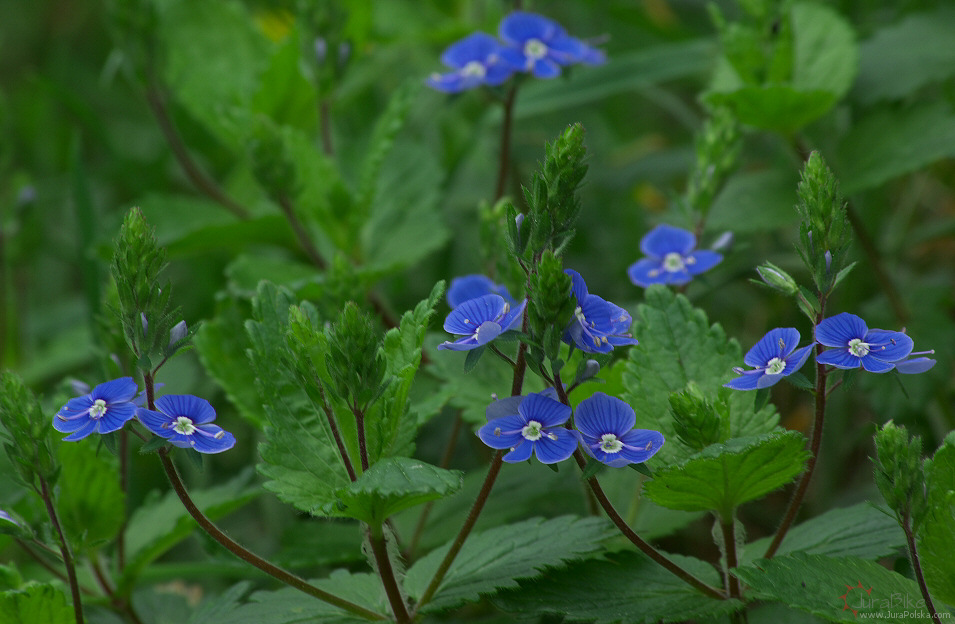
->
<box><xmin>405</xmin><ymin>516</ymin><xmax>611</xmax><ymax>612</ymax></box>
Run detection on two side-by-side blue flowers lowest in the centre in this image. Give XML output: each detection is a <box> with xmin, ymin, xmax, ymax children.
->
<box><xmin>478</xmin><ymin>389</ymin><xmax>663</xmax><ymax>467</ymax></box>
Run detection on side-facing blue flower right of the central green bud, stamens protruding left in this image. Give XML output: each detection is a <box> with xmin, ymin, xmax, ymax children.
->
<box><xmin>563</xmin><ymin>269</ymin><xmax>638</xmax><ymax>353</ymax></box>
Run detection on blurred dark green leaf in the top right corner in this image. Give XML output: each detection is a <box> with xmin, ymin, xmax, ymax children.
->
<box><xmin>852</xmin><ymin>5</ymin><xmax>955</xmax><ymax>104</ymax></box>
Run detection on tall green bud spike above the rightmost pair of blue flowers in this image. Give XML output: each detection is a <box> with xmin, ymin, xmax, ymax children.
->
<box><xmin>796</xmin><ymin>152</ymin><xmax>852</xmax><ymax>294</ymax></box>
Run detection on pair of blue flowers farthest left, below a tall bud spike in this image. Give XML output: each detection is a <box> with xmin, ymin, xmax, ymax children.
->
<box><xmin>53</xmin><ymin>377</ymin><xmax>235</xmax><ymax>453</ymax></box>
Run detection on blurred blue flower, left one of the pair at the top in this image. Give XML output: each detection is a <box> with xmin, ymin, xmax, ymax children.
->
<box><xmin>427</xmin><ymin>32</ymin><xmax>515</xmax><ymax>93</ymax></box>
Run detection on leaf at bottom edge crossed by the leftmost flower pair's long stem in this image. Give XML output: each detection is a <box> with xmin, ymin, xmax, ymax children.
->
<box><xmin>203</xmin><ymin>570</ymin><xmax>391</xmax><ymax>624</ymax></box>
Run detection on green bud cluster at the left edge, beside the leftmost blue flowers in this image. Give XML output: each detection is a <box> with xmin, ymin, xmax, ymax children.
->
<box><xmin>0</xmin><ymin>371</ymin><xmax>59</xmax><ymax>493</ymax></box>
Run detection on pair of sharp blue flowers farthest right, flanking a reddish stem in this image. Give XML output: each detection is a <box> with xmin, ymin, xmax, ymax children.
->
<box><xmin>724</xmin><ymin>312</ymin><xmax>935</xmax><ymax>390</ymax></box>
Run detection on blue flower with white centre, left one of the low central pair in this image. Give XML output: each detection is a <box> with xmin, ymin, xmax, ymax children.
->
<box><xmin>478</xmin><ymin>393</ymin><xmax>577</xmax><ymax>464</ymax></box>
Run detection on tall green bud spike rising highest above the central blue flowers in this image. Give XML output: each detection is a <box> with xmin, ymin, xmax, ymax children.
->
<box><xmin>510</xmin><ymin>124</ymin><xmax>587</xmax><ymax>258</ymax></box>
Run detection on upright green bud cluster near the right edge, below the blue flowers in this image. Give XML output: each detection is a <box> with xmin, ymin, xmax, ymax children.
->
<box><xmin>873</xmin><ymin>421</ymin><xmax>928</xmax><ymax>528</ymax></box>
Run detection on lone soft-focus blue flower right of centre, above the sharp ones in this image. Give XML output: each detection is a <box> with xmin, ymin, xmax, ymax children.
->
<box><xmin>627</xmin><ymin>224</ymin><xmax>723</xmax><ymax>288</ymax></box>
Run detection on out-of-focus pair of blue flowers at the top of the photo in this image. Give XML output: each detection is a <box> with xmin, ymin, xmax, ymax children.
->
<box><xmin>427</xmin><ymin>11</ymin><xmax>606</xmax><ymax>93</ymax></box>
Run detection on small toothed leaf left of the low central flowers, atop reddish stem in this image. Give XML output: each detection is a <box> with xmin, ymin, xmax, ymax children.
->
<box><xmin>323</xmin><ymin>457</ymin><xmax>461</xmax><ymax>525</ymax></box>
